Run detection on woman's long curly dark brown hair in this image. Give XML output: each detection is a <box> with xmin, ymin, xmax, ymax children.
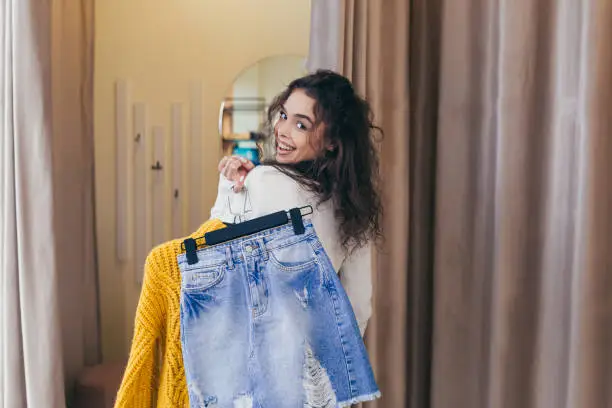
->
<box><xmin>264</xmin><ymin>70</ymin><xmax>383</xmax><ymax>252</ymax></box>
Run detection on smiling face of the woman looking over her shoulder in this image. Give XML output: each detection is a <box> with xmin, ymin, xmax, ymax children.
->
<box><xmin>274</xmin><ymin>89</ymin><xmax>323</xmax><ymax>163</ymax></box>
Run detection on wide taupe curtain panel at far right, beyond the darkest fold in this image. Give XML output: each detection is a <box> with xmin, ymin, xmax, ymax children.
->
<box><xmin>432</xmin><ymin>0</ymin><xmax>612</xmax><ymax>408</ymax></box>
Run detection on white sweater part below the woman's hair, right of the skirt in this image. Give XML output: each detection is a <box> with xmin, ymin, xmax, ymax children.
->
<box><xmin>340</xmin><ymin>245</ymin><xmax>372</xmax><ymax>336</ymax></box>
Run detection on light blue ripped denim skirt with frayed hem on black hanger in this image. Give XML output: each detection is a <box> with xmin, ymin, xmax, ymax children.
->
<box><xmin>178</xmin><ymin>222</ymin><xmax>380</xmax><ymax>408</ymax></box>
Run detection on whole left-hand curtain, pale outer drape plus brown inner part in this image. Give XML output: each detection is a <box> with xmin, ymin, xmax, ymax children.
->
<box><xmin>0</xmin><ymin>0</ymin><xmax>99</xmax><ymax>408</ymax></box>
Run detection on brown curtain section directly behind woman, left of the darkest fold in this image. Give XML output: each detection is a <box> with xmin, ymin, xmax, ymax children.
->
<box><xmin>309</xmin><ymin>0</ymin><xmax>414</xmax><ymax>407</ymax></box>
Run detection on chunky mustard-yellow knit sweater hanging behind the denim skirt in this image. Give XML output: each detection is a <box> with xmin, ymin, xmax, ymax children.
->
<box><xmin>115</xmin><ymin>220</ymin><xmax>225</xmax><ymax>408</ymax></box>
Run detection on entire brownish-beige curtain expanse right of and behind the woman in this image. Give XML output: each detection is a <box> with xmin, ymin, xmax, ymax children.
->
<box><xmin>311</xmin><ymin>0</ymin><xmax>612</xmax><ymax>408</ymax></box>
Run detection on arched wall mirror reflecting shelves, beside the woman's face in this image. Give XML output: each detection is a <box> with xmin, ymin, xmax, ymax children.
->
<box><xmin>219</xmin><ymin>55</ymin><xmax>306</xmax><ymax>163</ymax></box>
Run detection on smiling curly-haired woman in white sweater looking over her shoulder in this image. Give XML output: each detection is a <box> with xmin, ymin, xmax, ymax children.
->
<box><xmin>211</xmin><ymin>71</ymin><xmax>381</xmax><ymax>335</ymax></box>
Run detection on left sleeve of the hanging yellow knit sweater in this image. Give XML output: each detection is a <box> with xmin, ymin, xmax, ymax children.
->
<box><xmin>115</xmin><ymin>254</ymin><xmax>166</xmax><ymax>408</ymax></box>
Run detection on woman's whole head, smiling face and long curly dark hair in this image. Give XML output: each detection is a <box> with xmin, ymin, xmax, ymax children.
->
<box><xmin>265</xmin><ymin>70</ymin><xmax>382</xmax><ymax>251</ymax></box>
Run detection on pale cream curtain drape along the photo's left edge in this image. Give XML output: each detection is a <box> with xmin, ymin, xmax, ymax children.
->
<box><xmin>0</xmin><ymin>0</ymin><xmax>65</xmax><ymax>408</ymax></box>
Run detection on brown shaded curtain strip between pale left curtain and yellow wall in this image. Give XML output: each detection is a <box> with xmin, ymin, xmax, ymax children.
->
<box><xmin>51</xmin><ymin>0</ymin><xmax>101</xmax><ymax>391</ymax></box>
